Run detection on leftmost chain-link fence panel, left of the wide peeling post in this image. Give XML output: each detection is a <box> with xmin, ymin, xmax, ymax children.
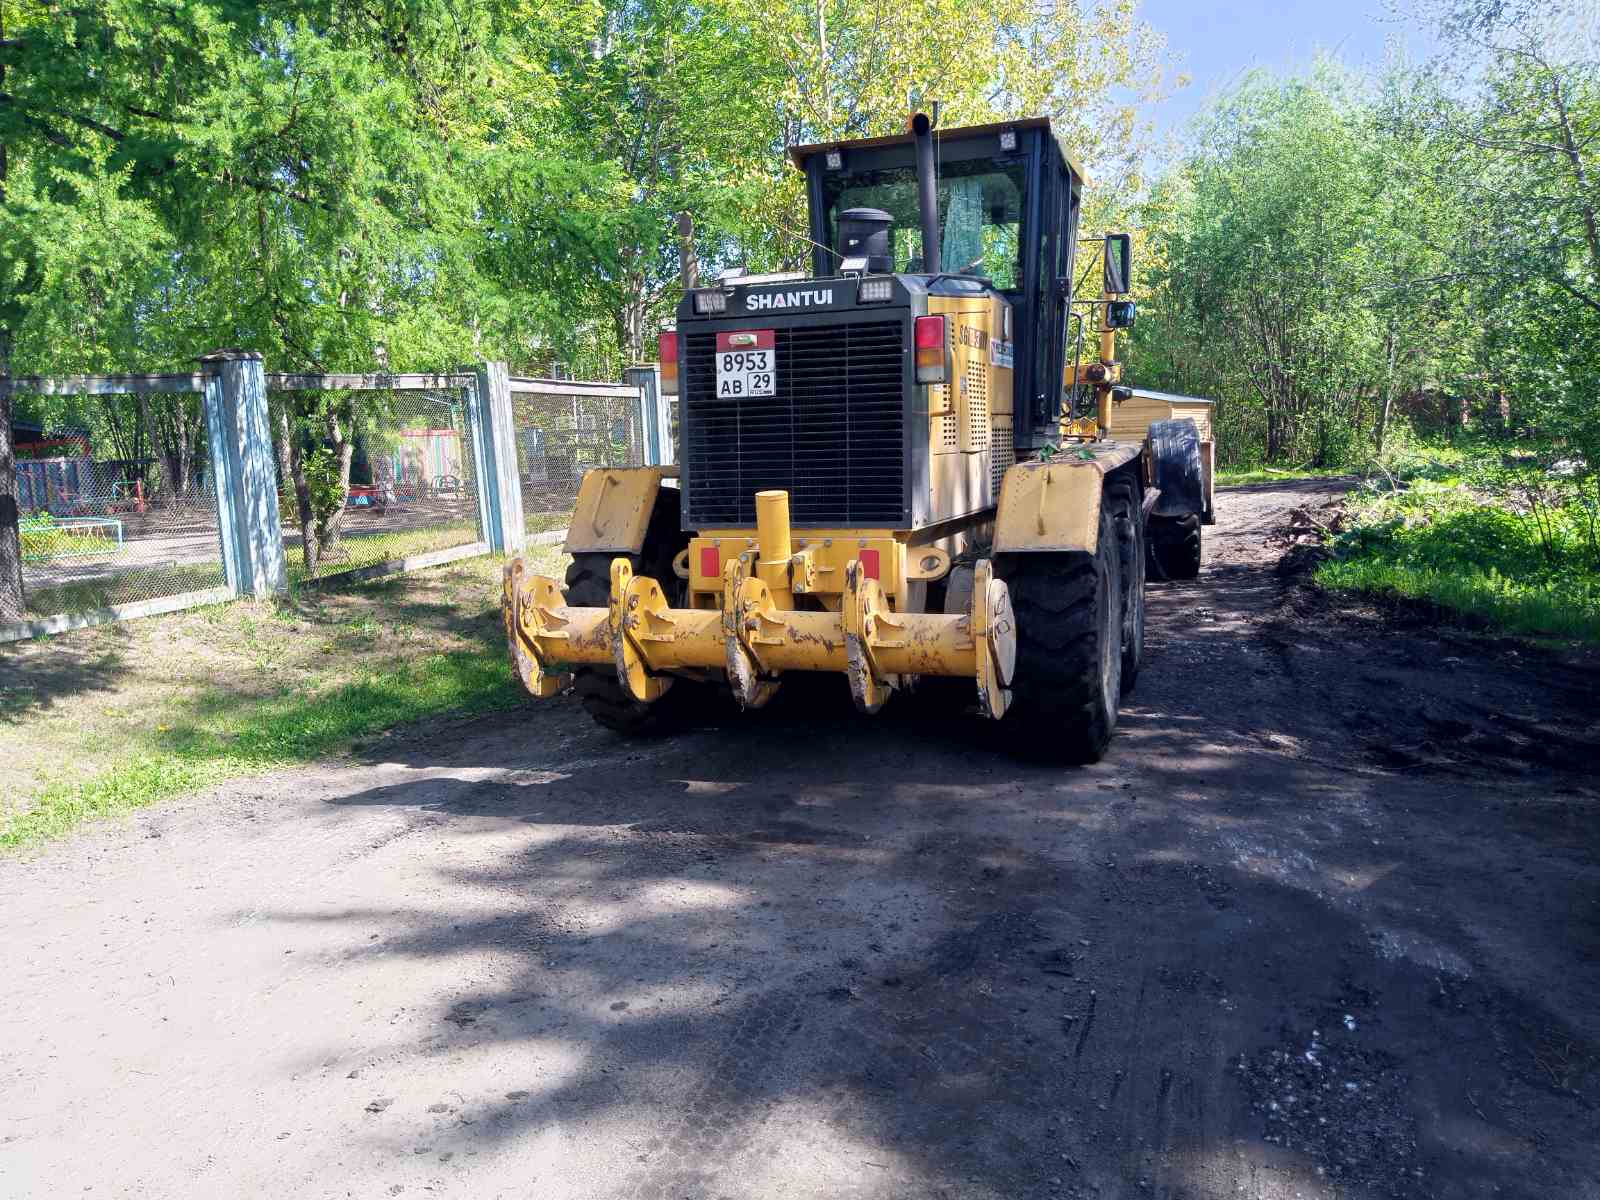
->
<box><xmin>14</xmin><ymin>392</ymin><xmax>224</xmax><ymax>618</ymax></box>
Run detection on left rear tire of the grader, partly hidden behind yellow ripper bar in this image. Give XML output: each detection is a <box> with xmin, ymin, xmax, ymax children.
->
<box><xmin>566</xmin><ymin>488</ymin><xmax>704</xmax><ymax>738</ymax></box>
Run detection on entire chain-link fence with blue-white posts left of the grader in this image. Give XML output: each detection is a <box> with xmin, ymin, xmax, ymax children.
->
<box><xmin>0</xmin><ymin>361</ymin><xmax>670</xmax><ymax>642</ymax></box>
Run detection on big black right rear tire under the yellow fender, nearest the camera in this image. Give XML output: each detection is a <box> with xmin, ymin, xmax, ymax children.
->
<box><xmin>995</xmin><ymin>504</ymin><xmax>1123</xmax><ymax>763</ymax></box>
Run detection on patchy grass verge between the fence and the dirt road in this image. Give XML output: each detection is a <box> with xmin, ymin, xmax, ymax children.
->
<box><xmin>0</xmin><ymin>546</ymin><xmax>565</xmax><ymax>850</ymax></box>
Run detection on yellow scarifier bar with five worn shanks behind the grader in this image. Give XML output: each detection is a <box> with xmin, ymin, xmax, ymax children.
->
<box><xmin>504</xmin><ymin>493</ymin><xmax>1016</xmax><ymax>718</ymax></box>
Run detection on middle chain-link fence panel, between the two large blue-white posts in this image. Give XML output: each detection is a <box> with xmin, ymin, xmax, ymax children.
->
<box><xmin>269</xmin><ymin>376</ymin><xmax>483</xmax><ymax>582</ymax></box>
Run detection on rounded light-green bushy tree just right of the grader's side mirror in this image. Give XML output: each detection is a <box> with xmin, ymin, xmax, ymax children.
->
<box><xmin>1133</xmin><ymin>62</ymin><xmax>1465</xmax><ymax>467</ymax></box>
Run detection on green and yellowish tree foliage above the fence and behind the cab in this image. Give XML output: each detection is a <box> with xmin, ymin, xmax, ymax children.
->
<box><xmin>0</xmin><ymin>0</ymin><xmax>1163</xmax><ymax>382</ymax></box>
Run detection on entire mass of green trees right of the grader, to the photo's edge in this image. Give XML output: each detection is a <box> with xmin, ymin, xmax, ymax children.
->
<box><xmin>1130</xmin><ymin>0</ymin><xmax>1600</xmax><ymax>483</ymax></box>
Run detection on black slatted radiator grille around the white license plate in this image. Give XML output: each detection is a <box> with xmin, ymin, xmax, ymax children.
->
<box><xmin>682</xmin><ymin>320</ymin><xmax>907</xmax><ymax>528</ymax></box>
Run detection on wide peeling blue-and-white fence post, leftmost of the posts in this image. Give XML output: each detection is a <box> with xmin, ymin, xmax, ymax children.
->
<box><xmin>198</xmin><ymin>350</ymin><xmax>290</xmax><ymax>597</ymax></box>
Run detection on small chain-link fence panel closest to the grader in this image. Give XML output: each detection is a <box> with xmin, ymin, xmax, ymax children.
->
<box><xmin>510</xmin><ymin>379</ymin><xmax>645</xmax><ymax>534</ymax></box>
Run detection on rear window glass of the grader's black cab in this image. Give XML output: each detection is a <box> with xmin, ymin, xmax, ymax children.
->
<box><xmin>822</xmin><ymin>158</ymin><xmax>1024</xmax><ymax>290</ymax></box>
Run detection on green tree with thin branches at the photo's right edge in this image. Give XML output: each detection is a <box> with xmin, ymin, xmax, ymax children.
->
<box><xmin>1397</xmin><ymin>0</ymin><xmax>1600</xmax><ymax>476</ymax></box>
